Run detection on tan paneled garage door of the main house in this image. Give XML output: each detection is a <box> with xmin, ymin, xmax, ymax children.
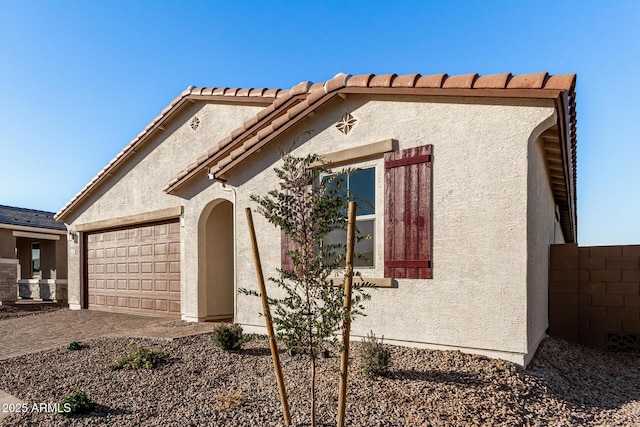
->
<box><xmin>85</xmin><ymin>221</ymin><xmax>180</xmax><ymax>317</ymax></box>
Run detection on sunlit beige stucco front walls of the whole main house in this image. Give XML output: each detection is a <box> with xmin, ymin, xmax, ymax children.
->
<box><xmin>61</xmin><ymin>91</ymin><xmax>554</xmax><ymax>363</ymax></box>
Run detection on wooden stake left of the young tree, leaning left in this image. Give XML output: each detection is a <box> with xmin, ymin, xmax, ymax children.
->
<box><xmin>244</xmin><ymin>208</ymin><xmax>291</xmax><ymax>426</ymax></box>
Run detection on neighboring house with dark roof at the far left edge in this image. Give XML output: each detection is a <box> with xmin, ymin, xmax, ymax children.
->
<box><xmin>0</xmin><ymin>205</ymin><xmax>67</xmax><ymax>304</ymax></box>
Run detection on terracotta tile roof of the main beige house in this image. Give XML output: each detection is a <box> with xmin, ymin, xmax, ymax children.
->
<box><xmin>56</xmin><ymin>72</ymin><xmax>577</xmax><ymax>242</ymax></box>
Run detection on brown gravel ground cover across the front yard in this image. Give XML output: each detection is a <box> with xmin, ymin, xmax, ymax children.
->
<box><xmin>0</xmin><ymin>334</ymin><xmax>640</xmax><ymax>426</ymax></box>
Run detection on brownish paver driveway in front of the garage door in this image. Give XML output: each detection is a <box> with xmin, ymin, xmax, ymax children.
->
<box><xmin>0</xmin><ymin>309</ymin><xmax>215</xmax><ymax>420</ymax></box>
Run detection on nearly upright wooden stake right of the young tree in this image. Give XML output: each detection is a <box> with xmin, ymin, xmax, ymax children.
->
<box><xmin>338</xmin><ymin>202</ymin><xmax>356</xmax><ymax>427</ymax></box>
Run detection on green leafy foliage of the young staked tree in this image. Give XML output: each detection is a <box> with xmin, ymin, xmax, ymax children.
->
<box><xmin>249</xmin><ymin>154</ymin><xmax>370</xmax><ymax>359</ymax></box>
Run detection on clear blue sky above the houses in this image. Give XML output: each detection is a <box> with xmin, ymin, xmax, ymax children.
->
<box><xmin>0</xmin><ymin>0</ymin><xmax>640</xmax><ymax>245</ymax></box>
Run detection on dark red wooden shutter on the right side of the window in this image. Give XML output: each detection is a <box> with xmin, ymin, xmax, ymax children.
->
<box><xmin>384</xmin><ymin>145</ymin><xmax>433</xmax><ymax>279</ymax></box>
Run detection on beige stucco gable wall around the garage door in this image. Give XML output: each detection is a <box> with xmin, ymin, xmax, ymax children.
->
<box><xmin>65</xmin><ymin>102</ymin><xmax>263</xmax><ymax>311</ymax></box>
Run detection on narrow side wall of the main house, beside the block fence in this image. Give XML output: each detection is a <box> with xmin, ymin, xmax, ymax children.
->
<box><xmin>526</xmin><ymin>130</ymin><xmax>564</xmax><ymax>362</ymax></box>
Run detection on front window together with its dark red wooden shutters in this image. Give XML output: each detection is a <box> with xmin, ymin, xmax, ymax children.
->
<box><xmin>280</xmin><ymin>145</ymin><xmax>433</xmax><ymax>279</ymax></box>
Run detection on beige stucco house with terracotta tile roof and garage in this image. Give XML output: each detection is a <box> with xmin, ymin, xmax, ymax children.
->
<box><xmin>56</xmin><ymin>73</ymin><xmax>576</xmax><ymax>364</ymax></box>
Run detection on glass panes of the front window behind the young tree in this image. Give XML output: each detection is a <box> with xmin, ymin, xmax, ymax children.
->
<box><xmin>324</xmin><ymin>167</ymin><xmax>376</xmax><ymax>267</ymax></box>
